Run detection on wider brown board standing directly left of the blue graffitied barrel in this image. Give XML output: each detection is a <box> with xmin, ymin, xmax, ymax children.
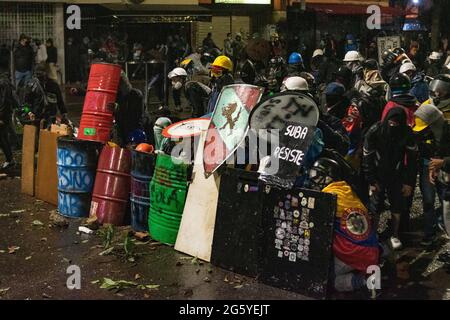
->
<box><xmin>35</xmin><ymin>130</ymin><xmax>60</xmax><ymax>205</ymax></box>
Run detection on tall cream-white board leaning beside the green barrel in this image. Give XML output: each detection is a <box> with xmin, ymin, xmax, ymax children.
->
<box><xmin>175</xmin><ymin>132</ymin><xmax>220</xmax><ymax>262</ymax></box>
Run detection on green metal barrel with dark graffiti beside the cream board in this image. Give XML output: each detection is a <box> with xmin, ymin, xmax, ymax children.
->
<box><xmin>148</xmin><ymin>154</ymin><xmax>189</xmax><ymax>244</ymax></box>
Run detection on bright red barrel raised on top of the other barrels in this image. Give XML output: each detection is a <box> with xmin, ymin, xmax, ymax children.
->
<box><xmin>77</xmin><ymin>63</ymin><xmax>121</xmax><ymax>143</ymax></box>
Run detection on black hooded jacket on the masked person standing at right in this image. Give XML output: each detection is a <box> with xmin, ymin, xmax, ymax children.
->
<box><xmin>362</xmin><ymin>107</ymin><xmax>418</xmax><ymax>186</ymax></box>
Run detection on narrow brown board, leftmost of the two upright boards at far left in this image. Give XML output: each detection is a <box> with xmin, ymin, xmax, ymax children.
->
<box><xmin>21</xmin><ymin>125</ymin><xmax>37</xmax><ymax>196</ymax></box>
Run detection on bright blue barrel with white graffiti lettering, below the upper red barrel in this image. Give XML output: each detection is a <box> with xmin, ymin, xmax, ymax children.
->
<box><xmin>57</xmin><ymin>137</ymin><xmax>102</xmax><ymax>218</ymax></box>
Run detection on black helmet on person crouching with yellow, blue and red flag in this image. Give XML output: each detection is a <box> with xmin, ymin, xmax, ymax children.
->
<box><xmin>308</xmin><ymin>158</ymin><xmax>343</xmax><ymax>190</ymax></box>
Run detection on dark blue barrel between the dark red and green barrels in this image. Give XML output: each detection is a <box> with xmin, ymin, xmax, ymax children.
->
<box><xmin>130</xmin><ymin>150</ymin><xmax>156</xmax><ymax>232</ymax></box>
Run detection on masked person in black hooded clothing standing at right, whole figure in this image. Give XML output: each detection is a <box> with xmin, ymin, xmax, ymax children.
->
<box><xmin>363</xmin><ymin>107</ymin><xmax>417</xmax><ymax>250</ymax></box>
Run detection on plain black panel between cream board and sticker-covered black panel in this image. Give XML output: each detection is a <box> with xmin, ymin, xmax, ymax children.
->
<box><xmin>211</xmin><ymin>168</ymin><xmax>263</xmax><ymax>277</ymax></box>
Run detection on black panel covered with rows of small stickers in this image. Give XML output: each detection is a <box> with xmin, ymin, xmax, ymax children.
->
<box><xmin>260</xmin><ymin>186</ymin><xmax>336</xmax><ymax>299</ymax></box>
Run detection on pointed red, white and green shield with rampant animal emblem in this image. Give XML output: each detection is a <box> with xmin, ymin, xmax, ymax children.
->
<box><xmin>203</xmin><ymin>84</ymin><xmax>263</xmax><ymax>177</ymax></box>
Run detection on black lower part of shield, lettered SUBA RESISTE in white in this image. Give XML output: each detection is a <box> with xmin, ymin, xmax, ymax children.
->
<box><xmin>260</xmin><ymin>122</ymin><xmax>316</xmax><ymax>189</ymax></box>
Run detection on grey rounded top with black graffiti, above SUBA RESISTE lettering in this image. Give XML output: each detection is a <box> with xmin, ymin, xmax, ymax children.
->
<box><xmin>249</xmin><ymin>93</ymin><xmax>319</xmax><ymax>130</ymax></box>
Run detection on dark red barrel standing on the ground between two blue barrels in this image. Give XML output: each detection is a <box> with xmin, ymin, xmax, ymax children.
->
<box><xmin>90</xmin><ymin>145</ymin><xmax>131</xmax><ymax>226</ymax></box>
